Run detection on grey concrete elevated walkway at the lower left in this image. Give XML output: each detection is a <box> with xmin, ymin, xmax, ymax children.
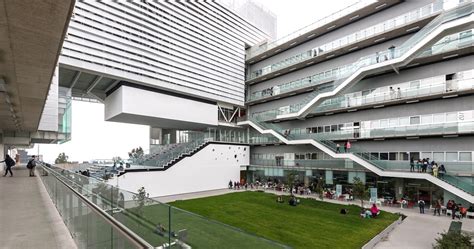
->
<box><xmin>0</xmin><ymin>164</ymin><xmax>77</xmax><ymax>249</ymax></box>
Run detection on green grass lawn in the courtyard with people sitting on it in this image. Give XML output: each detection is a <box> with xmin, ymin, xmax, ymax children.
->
<box><xmin>170</xmin><ymin>192</ymin><xmax>398</xmax><ymax>248</ymax></box>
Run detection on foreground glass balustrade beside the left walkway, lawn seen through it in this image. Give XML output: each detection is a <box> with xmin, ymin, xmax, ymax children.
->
<box><xmin>40</xmin><ymin>166</ymin><xmax>288</xmax><ymax>248</ymax></box>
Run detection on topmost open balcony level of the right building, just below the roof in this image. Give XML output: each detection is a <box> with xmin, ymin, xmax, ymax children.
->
<box><xmin>246</xmin><ymin>2</ymin><xmax>443</xmax><ymax>84</ymax></box>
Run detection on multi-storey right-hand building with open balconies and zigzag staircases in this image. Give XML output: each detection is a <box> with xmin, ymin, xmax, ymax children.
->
<box><xmin>238</xmin><ymin>1</ymin><xmax>474</xmax><ymax>205</ymax></box>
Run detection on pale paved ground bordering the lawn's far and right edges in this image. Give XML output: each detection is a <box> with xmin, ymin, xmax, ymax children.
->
<box><xmin>156</xmin><ymin>189</ymin><xmax>474</xmax><ymax>249</ymax></box>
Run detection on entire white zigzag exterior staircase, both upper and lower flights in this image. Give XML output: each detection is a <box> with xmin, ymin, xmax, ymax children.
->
<box><xmin>238</xmin><ymin>3</ymin><xmax>474</xmax><ymax>203</ymax></box>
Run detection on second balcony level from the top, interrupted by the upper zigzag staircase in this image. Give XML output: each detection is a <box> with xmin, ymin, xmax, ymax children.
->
<box><xmin>247</xmin><ymin>30</ymin><xmax>474</xmax><ymax>108</ymax></box>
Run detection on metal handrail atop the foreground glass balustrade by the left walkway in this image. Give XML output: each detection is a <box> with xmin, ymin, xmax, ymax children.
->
<box><xmin>40</xmin><ymin>163</ymin><xmax>155</xmax><ymax>248</ymax></box>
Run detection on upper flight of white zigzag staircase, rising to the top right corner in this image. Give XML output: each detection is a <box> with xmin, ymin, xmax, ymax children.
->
<box><xmin>276</xmin><ymin>3</ymin><xmax>474</xmax><ymax>119</ymax></box>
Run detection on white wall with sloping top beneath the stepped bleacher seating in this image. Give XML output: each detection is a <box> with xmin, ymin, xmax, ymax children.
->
<box><xmin>113</xmin><ymin>144</ymin><xmax>250</xmax><ymax>197</ymax></box>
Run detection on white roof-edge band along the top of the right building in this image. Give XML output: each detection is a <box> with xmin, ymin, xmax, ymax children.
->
<box><xmin>246</xmin><ymin>0</ymin><xmax>400</xmax><ymax>63</ymax></box>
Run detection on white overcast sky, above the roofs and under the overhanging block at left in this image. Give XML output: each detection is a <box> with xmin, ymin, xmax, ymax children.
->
<box><xmin>28</xmin><ymin>0</ymin><xmax>356</xmax><ymax>163</ymax></box>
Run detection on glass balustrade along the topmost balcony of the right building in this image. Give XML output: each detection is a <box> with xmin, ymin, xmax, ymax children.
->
<box><xmin>247</xmin><ymin>2</ymin><xmax>443</xmax><ymax>80</ymax></box>
